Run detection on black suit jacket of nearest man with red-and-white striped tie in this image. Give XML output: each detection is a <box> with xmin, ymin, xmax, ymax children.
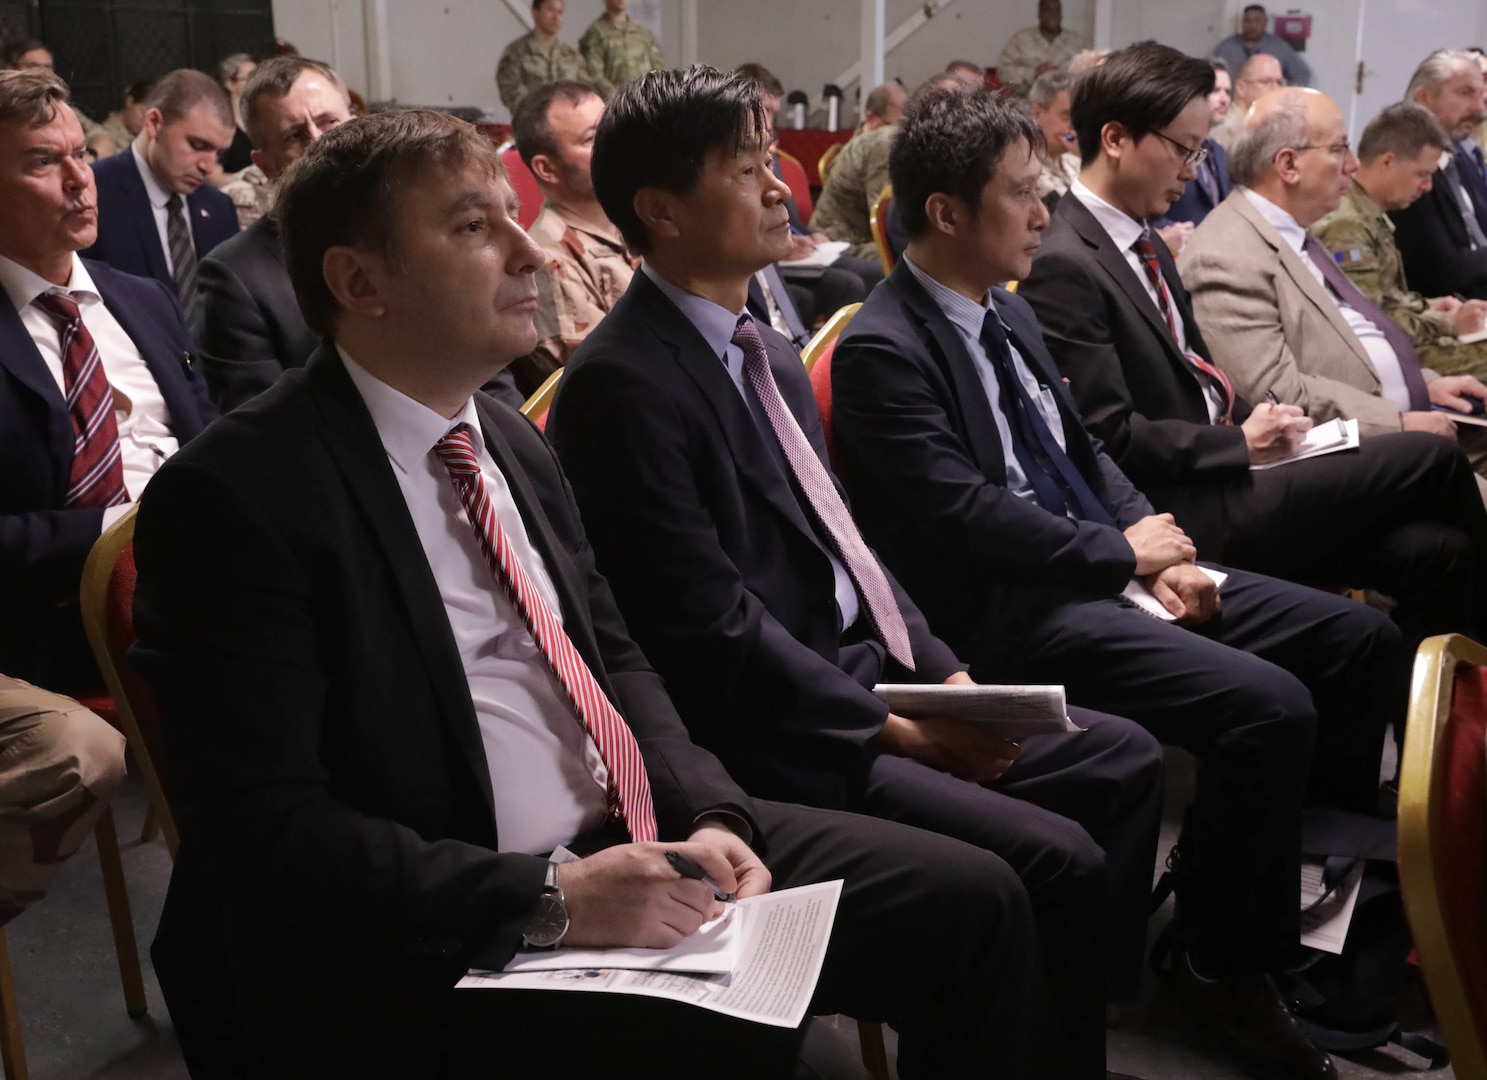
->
<box><xmin>134</xmin><ymin>344</ymin><xmax>752</xmax><ymax>1076</ymax></box>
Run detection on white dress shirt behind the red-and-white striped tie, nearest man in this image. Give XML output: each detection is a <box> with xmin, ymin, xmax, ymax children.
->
<box><xmin>339</xmin><ymin>350</ymin><xmax>608</xmax><ymax>855</ymax></box>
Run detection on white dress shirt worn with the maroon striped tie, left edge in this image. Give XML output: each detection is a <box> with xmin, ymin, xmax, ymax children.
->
<box><xmin>0</xmin><ymin>254</ymin><xmax>180</xmax><ymax>528</ymax></box>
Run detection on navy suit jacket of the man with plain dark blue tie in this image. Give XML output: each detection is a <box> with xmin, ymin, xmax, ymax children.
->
<box><xmin>831</xmin><ymin>262</ymin><xmax>1152</xmax><ymax>652</ymax></box>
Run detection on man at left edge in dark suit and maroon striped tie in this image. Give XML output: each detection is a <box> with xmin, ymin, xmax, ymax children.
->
<box><xmin>0</xmin><ymin>70</ymin><xmax>216</xmax><ymax>690</ymax></box>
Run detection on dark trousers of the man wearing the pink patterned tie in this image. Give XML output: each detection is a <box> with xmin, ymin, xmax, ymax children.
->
<box><xmin>852</xmin><ymin>710</ymin><xmax>1163</xmax><ymax>1077</ymax></box>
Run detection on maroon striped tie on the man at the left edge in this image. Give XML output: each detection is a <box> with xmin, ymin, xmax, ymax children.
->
<box><xmin>36</xmin><ymin>293</ymin><xmax>129</xmax><ymax>507</ymax></box>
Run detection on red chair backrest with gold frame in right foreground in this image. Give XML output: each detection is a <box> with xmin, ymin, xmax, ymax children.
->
<box><xmin>1399</xmin><ymin>634</ymin><xmax>1487</xmax><ymax>1077</ymax></box>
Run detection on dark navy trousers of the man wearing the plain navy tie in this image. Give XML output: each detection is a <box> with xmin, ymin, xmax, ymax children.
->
<box><xmin>971</xmin><ymin>570</ymin><xmax>1408</xmax><ymax>974</ymax></box>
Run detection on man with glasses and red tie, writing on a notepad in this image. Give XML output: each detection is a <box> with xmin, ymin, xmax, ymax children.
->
<box><xmin>1019</xmin><ymin>43</ymin><xmax>1487</xmax><ymax>652</ymax></box>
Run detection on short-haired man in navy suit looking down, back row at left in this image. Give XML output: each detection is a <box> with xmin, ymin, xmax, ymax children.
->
<box><xmin>83</xmin><ymin>68</ymin><xmax>238</xmax><ymax>323</ymax></box>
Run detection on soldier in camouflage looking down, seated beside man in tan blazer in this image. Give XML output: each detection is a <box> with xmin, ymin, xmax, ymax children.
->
<box><xmin>1312</xmin><ymin>103</ymin><xmax>1487</xmax><ymax>378</ymax></box>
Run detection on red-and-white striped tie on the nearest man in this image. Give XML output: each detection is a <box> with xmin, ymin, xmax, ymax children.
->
<box><xmin>434</xmin><ymin>424</ymin><xmax>656</xmax><ymax>840</ymax></box>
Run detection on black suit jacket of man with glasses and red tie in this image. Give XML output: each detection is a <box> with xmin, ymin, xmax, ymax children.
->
<box><xmin>1017</xmin><ymin>198</ymin><xmax>1251</xmax><ymax>558</ymax></box>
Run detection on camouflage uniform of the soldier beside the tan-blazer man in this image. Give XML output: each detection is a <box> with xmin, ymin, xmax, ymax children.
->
<box><xmin>1312</xmin><ymin>180</ymin><xmax>1487</xmax><ymax>378</ymax></box>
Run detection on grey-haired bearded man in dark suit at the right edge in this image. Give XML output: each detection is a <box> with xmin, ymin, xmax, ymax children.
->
<box><xmin>1389</xmin><ymin>49</ymin><xmax>1487</xmax><ymax>300</ymax></box>
